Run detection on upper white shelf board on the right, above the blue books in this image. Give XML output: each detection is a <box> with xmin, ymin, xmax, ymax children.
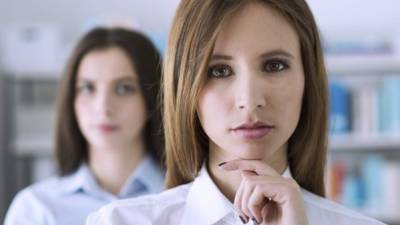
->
<box><xmin>325</xmin><ymin>54</ymin><xmax>400</xmax><ymax>76</ymax></box>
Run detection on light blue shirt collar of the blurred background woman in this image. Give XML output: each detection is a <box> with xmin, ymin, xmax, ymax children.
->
<box><xmin>56</xmin><ymin>155</ymin><xmax>164</xmax><ymax>198</ymax></box>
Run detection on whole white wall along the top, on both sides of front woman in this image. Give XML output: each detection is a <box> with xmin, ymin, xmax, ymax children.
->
<box><xmin>0</xmin><ymin>0</ymin><xmax>400</xmax><ymax>38</ymax></box>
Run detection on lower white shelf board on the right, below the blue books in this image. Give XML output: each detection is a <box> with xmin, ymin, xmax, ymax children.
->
<box><xmin>329</xmin><ymin>135</ymin><xmax>400</xmax><ymax>152</ymax></box>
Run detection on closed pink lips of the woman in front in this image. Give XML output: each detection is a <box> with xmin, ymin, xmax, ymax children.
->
<box><xmin>231</xmin><ymin>122</ymin><xmax>274</xmax><ymax>140</ymax></box>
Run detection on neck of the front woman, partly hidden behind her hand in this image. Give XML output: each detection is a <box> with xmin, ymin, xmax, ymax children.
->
<box><xmin>207</xmin><ymin>146</ymin><xmax>288</xmax><ymax>202</ymax></box>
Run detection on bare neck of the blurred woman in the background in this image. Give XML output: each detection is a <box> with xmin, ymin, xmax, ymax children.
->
<box><xmin>88</xmin><ymin>142</ymin><xmax>145</xmax><ymax>196</ymax></box>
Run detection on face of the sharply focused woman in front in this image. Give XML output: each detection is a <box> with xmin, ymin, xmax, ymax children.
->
<box><xmin>197</xmin><ymin>2</ymin><xmax>304</xmax><ymax>162</ymax></box>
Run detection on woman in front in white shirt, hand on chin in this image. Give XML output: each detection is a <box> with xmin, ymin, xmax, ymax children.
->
<box><xmin>87</xmin><ymin>0</ymin><xmax>381</xmax><ymax>225</ymax></box>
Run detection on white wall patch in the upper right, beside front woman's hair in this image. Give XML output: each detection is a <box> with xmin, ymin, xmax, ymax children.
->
<box><xmin>307</xmin><ymin>0</ymin><xmax>400</xmax><ymax>36</ymax></box>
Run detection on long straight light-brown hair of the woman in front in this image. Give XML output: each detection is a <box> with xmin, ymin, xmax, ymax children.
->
<box><xmin>163</xmin><ymin>0</ymin><xmax>328</xmax><ymax>196</ymax></box>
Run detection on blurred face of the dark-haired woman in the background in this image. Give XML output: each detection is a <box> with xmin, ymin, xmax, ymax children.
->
<box><xmin>74</xmin><ymin>47</ymin><xmax>146</xmax><ymax>149</ymax></box>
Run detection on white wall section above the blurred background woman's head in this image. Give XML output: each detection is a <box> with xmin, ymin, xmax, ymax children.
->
<box><xmin>0</xmin><ymin>0</ymin><xmax>179</xmax><ymax>40</ymax></box>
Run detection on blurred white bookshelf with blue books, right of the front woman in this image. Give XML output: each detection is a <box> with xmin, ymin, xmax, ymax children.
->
<box><xmin>325</xmin><ymin>54</ymin><xmax>400</xmax><ymax>225</ymax></box>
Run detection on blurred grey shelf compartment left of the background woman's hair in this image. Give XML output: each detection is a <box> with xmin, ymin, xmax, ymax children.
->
<box><xmin>6</xmin><ymin>71</ymin><xmax>61</xmax><ymax>158</ymax></box>
